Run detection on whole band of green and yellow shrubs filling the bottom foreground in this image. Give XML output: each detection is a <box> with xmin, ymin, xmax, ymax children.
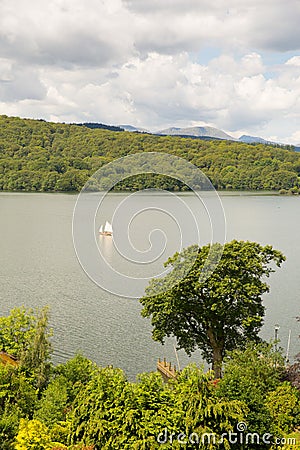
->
<box><xmin>0</xmin><ymin>304</ymin><xmax>300</xmax><ymax>450</ymax></box>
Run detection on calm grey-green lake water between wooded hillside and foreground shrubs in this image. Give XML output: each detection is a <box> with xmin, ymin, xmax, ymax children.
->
<box><xmin>0</xmin><ymin>193</ymin><xmax>300</xmax><ymax>378</ymax></box>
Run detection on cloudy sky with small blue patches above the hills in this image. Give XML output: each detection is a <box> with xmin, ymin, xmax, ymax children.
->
<box><xmin>0</xmin><ymin>0</ymin><xmax>300</xmax><ymax>144</ymax></box>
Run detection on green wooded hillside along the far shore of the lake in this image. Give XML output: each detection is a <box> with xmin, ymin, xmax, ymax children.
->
<box><xmin>0</xmin><ymin>116</ymin><xmax>300</xmax><ymax>191</ymax></box>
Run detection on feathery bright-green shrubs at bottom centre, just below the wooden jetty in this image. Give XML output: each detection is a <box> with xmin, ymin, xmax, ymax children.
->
<box><xmin>69</xmin><ymin>366</ymin><xmax>245</xmax><ymax>450</ymax></box>
